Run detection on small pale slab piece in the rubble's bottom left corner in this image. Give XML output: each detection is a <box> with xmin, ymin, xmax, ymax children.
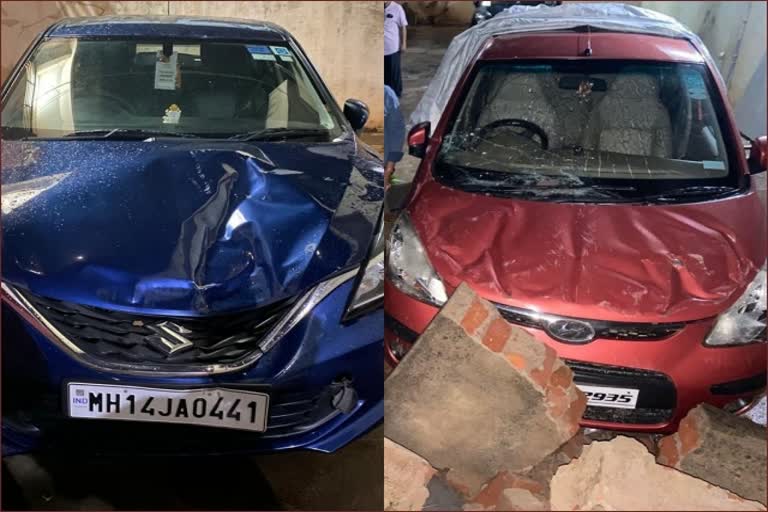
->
<box><xmin>384</xmin><ymin>437</ymin><xmax>437</xmax><ymax>510</ymax></box>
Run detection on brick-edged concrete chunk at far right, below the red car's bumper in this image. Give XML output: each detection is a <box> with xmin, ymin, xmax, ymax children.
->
<box><xmin>656</xmin><ymin>404</ymin><xmax>768</xmax><ymax>504</ymax></box>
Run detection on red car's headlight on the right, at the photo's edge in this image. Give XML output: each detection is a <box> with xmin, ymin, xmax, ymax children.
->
<box><xmin>704</xmin><ymin>265</ymin><xmax>766</xmax><ymax>347</ymax></box>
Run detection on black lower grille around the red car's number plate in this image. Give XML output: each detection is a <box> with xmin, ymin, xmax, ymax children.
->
<box><xmin>564</xmin><ymin>360</ymin><xmax>677</xmax><ymax>425</ymax></box>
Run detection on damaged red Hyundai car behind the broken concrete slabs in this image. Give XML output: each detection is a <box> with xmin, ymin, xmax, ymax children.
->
<box><xmin>385</xmin><ymin>30</ymin><xmax>768</xmax><ymax>433</ymax></box>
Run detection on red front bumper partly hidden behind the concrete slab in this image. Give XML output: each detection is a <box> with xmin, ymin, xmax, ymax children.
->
<box><xmin>384</xmin><ymin>281</ymin><xmax>766</xmax><ymax>433</ymax></box>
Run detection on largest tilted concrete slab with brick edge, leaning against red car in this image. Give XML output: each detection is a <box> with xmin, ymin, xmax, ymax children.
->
<box><xmin>384</xmin><ymin>284</ymin><xmax>586</xmax><ymax>496</ymax></box>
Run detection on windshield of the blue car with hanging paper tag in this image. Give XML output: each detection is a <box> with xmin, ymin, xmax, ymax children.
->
<box><xmin>2</xmin><ymin>38</ymin><xmax>341</xmax><ymax>140</ymax></box>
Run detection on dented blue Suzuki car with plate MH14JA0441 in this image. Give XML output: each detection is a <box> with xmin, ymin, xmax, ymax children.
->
<box><xmin>2</xmin><ymin>17</ymin><xmax>384</xmax><ymax>455</ymax></box>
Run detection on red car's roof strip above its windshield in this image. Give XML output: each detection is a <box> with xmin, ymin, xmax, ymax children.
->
<box><xmin>478</xmin><ymin>30</ymin><xmax>705</xmax><ymax>63</ymax></box>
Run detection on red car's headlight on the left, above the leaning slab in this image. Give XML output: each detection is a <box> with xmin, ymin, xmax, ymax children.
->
<box><xmin>387</xmin><ymin>213</ymin><xmax>448</xmax><ymax>306</ymax></box>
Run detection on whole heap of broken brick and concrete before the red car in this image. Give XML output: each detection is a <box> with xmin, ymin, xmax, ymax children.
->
<box><xmin>384</xmin><ymin>284</ymin><xmax>766</xmax><ymax>511</ymax></box>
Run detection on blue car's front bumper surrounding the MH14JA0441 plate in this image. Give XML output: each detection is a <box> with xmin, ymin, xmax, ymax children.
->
<box><xmin>2</xmin><ymin>279</ymin><xmax>384</xmax><ymax>456</ymax></box>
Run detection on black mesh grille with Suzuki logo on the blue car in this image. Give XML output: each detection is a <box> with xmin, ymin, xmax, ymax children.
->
<box><xmin>21</xmin><ymin>292</ymin><xmax>295</xmax><ymax>370</ymax></box>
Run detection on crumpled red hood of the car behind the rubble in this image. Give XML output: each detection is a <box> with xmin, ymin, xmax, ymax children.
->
<box><xmin>409</xmin><ymin>179</ymin><xmax>766</xmax><ymax>322</ymax></box>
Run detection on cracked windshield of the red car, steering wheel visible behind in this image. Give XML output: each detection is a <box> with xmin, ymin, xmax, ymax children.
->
<box><xmin>436</xmin><ymin>60</ymin><xmax>739</xmax><ymax>201</ymax></box>
